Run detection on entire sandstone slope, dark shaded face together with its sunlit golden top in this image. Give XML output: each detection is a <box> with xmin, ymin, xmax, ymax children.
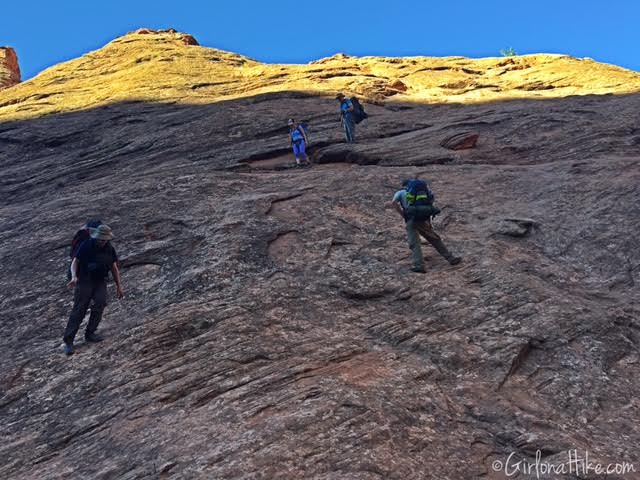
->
<box><xmin>0</xmin><ymin>33</ymin><xmax>640</xmax><ymax>480</ymax></box>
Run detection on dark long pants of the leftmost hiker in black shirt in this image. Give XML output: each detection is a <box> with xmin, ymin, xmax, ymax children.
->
<box><xmin>64</xmin><ymin>280</ymin><xmax>107</xmax><ymax>344</ymax></box>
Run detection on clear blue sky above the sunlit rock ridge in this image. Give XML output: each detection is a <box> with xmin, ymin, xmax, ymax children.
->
<box><xmin>5</xmin><ymin>0</ymin><xmax>640</xmax><ymax>79</ymax></box>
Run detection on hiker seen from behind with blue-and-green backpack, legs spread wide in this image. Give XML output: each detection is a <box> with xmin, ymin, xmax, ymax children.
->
<box><xmin>392</xmin><ymin>178</ymin><xmax>462</xmax><ymax>273</ymax></box>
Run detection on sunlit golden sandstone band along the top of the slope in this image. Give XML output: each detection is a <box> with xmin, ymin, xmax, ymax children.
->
<box><xmin>0</xmin><ymin>29</ymin><xmax>640</xmax><ymax>122</ymax></box>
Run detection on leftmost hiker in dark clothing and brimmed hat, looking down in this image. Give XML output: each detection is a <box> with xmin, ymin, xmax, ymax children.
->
<box><xmin>63</xmin><ymin>224</ymin><xmax>124</xmax><ymax>355</ymax></box>
